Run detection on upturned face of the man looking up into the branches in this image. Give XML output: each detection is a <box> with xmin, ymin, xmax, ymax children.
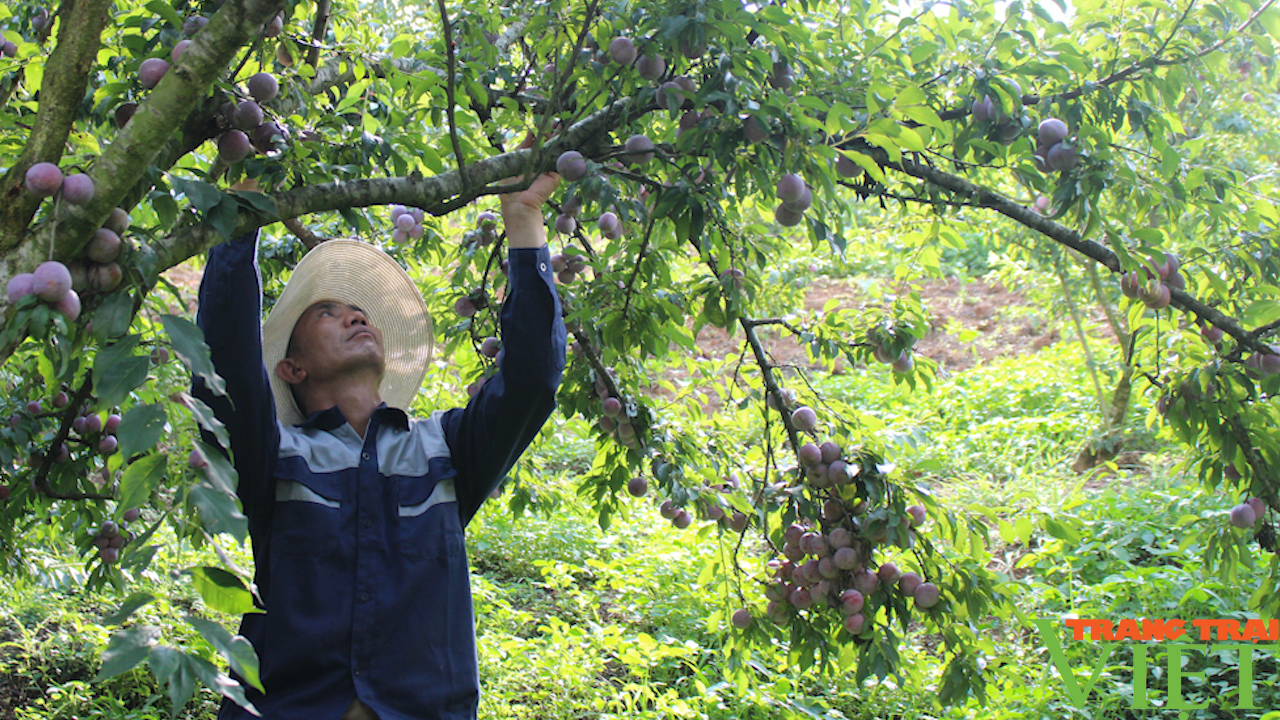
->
<box><xmin>288</xmin><ymin>300</ymin><xmax>385</xmax><ymax>380</ymax></box>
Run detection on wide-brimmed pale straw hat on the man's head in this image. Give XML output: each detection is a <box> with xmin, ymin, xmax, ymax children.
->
<box><xmin>262</xmin><ymin>240</ymin><xmax>433</xmax><ymax>425</ymax></box>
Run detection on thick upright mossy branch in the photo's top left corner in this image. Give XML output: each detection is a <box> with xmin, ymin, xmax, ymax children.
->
<box><xmin>0</xmin><ymin>0</ymin><xmax>111</xmax><ymax>243</ymax></box>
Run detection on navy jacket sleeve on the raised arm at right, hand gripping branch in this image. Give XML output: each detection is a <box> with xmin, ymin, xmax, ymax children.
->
<box><xmin>442</xmin><ymin>246</ymin><xmax>566</xmax><ymax>525</ymax></box>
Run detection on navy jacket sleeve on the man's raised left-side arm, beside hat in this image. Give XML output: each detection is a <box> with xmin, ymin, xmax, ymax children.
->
<box><xmin>192</xmin><ymin>232</ymin><xmax>280</xmax><ymax>527</ymax></box>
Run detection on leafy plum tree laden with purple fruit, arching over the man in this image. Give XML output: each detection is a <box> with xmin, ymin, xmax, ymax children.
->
<box><xmin>0</xmin><ymin>0</ymin><xmax>1280</xmax><ymax>701</ymax></box>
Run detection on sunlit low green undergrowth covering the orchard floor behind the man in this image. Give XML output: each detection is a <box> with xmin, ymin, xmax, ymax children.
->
<box><xmin>0</xmin><ymin>322</ymin><xmax>1259</xmax><ymax>720</ymax></box>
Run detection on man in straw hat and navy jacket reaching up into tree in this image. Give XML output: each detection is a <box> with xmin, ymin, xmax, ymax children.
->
<box><xmin>193</xmin><ymin>167</ymin><xmax>564</xmax><ymax>720</ymax></box>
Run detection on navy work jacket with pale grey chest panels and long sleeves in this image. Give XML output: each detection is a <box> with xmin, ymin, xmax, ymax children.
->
<box><xmin>193</xmin><ymin>236</ymin><xmax>564</xmax><ymax>720</ymax></box>
